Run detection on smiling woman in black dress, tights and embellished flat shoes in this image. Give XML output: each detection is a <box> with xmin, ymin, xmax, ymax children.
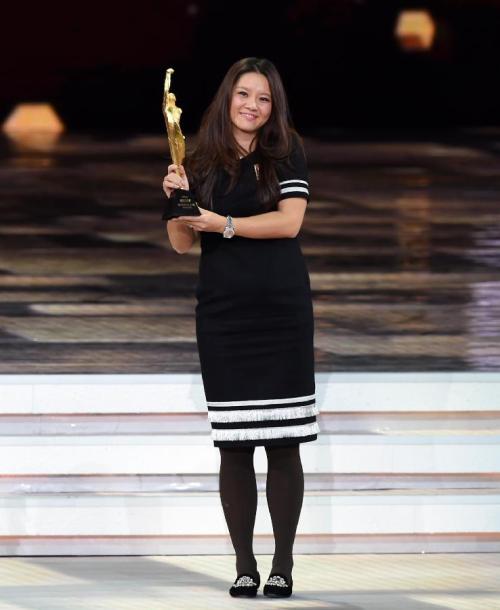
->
<box><xmin>163</xmin><ymin>58</ymin><xmax>319</xmax><ymax>597</ymax></box>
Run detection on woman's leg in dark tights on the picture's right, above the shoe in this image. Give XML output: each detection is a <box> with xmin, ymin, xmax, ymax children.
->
<box><xmin>266</xmin><ymin>443</ymin><xmax>304</xmax><ymax>579</ymax></box>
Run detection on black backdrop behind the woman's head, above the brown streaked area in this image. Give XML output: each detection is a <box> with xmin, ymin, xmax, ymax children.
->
<box><xmin>0</xmin><ymin>0</ymin><xmax>500</xmax><ymax>133</ymax></box>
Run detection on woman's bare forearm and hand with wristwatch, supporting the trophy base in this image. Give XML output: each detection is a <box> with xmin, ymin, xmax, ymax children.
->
<box><xmin>178</xmin><ymin>197</ymin><xmax>307</xmax><ymax>239</ymax></box>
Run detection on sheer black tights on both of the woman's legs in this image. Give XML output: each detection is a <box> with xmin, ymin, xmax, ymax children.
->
<box><xmin>219</xmin><ymin>443</ymin><xmax>304</xmax><ymax>577</ymax></box>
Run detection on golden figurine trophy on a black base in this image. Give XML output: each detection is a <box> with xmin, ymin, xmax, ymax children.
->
<box><xmin>162</xmin><ymin>68</ymin><xmax>200</xmax><ymax>220</ymax></box>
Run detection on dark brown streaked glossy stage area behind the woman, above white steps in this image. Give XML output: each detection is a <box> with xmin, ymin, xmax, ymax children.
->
<box><xmin>0</xmin><ymin>132</ymin><xmax>500</xmax><ymax>374</ymax></box>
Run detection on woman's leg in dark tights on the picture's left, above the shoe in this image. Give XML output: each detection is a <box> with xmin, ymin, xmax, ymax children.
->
<box><xmin>219</xmin><ymin>447</ymin><xmax>257</xmax><ymax>576</ymax></box>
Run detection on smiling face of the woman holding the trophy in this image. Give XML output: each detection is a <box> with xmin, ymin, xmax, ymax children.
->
<box><xmin>229</xmin><ymin>72</ymin><xmax>272</xmax><ymax>137</ymax></box>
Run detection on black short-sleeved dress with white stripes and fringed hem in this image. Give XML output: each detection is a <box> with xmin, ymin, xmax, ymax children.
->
<box><xmin>196</xmin><ymin>145</ymin><xmax>319</xmax><ymax>447</ymax></box>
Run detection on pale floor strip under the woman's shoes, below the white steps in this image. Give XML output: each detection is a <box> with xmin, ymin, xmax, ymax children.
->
<box><xmin>0</xmin><ymin>553</ymin><xmax>500</xmax><ymax>610</ymax></box>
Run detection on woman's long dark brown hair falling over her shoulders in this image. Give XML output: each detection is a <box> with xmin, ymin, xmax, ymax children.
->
<box><xmin>185</xmin><ymin>57</ymin><xmax>300</xmax><ymax>209</ymax></box>
